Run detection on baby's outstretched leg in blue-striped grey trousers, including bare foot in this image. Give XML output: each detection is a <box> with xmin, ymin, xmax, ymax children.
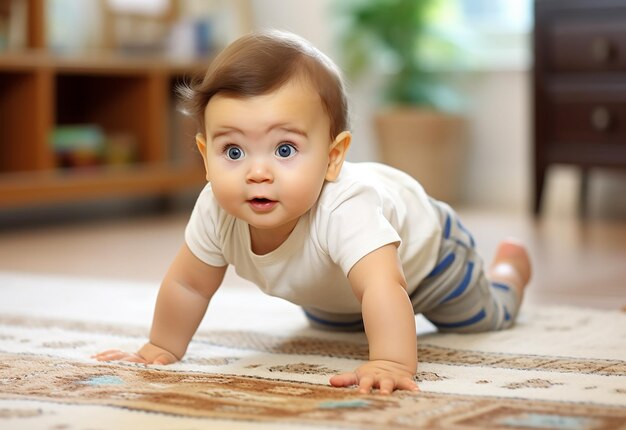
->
<box><xmin>410</xmin><ymin>200</ymin><xmax>531</xmax><ymax>333</ymax></box>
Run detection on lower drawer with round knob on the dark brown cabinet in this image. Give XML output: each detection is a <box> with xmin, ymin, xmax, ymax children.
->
<box><xmin>546</xmin><ymin>90</ymin><xmax>626</xmax><ymax>146</ymax></box>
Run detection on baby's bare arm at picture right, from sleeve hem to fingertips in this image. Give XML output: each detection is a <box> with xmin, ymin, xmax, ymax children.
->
<box><xmin>330</xmin><ymin>244</ymin><xmax>418</xmax><ymax>394</ymax></box>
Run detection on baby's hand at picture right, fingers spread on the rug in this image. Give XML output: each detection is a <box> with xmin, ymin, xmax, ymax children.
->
<box><xmin>330</xmin><ymin>360</ymin><xmax>419</xmax><ymax>394</ymax></box>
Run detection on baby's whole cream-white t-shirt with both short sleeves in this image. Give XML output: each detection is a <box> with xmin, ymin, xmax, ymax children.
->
<box><xmin>185</xmin><ymin>162</ymin><xmax>441</xmax><ymax>313</ymax></box>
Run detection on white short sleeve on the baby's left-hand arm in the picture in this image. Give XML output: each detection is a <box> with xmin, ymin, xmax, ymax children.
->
<box><xmin>185</xmin><ymin>184</ymin><xmax>227</xmax><ymax>267</ymax></box>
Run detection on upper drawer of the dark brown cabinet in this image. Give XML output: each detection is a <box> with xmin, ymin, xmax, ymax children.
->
<box><xmin>546</xmin><ymin>8</ymin><xmax>626</xmax><ymax>72</ymax></box>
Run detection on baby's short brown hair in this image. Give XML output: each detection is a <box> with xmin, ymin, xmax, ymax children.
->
<box><xmin>178</xmin><ymin>30</ymin><xmax>348</xmax><ymax>140</ymax></box>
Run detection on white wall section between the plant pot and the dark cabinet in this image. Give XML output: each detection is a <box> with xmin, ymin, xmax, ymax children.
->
<box><xmin>450</xmin><ymin>70</ymin><xmax>532</xmax><ymax>211</ymax></box>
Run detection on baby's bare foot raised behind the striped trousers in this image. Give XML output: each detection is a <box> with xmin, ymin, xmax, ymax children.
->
<box><xmin>489</xmin><ymin>239</ymin><xmax>532</xmax><ymax>294</ymax></box>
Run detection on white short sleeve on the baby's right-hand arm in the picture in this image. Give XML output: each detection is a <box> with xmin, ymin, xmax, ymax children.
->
<box><xmin>326</xmin><ymin>186</ymin><xmax>401</xmax><ymax>276</ymax></box>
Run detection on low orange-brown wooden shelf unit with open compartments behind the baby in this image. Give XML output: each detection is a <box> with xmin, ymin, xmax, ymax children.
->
<box><xmin>0</xmin><ymin>0</ymin><xmax>207</xmax><ymax>210</ymax></box>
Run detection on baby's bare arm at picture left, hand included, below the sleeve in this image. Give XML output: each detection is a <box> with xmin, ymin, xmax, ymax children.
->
<box><xmin>94</xmin><ymin>245</ymin><xmax>227</xmax><ymax>364</ymax></box>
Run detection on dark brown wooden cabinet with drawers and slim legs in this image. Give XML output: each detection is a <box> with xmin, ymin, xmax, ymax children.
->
<box><xmin>534</xmin><ymin>0</ymin><xmax>626</xmax><ymax>213</ymax></box>
